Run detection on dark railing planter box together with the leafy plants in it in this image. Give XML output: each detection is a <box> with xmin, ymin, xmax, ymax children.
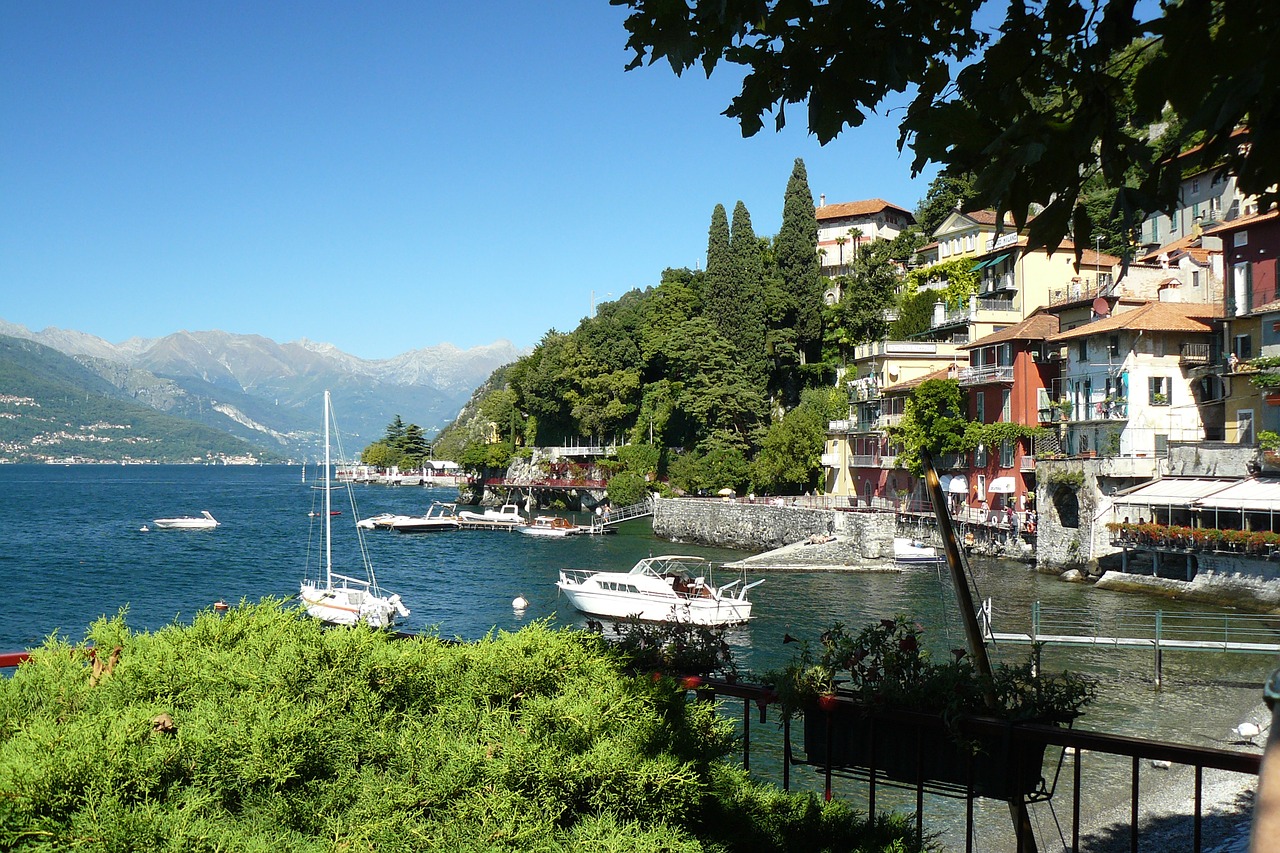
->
<box><xmin>764</xmin><ymin>617</ymin><xmax>1094</xmax><ymax>799</ymax></box>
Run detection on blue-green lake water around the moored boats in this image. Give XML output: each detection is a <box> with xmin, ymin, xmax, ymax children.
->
<box><xmin>0</xmin><ymin>465</ymin><xmax>1275</xmax><ymax>849</ymax></box>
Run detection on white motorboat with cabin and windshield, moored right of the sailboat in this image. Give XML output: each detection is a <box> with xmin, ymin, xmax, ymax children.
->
<box><xmin>556</xmin><ymin>555</ymin><xmax>764</xmax><ymax>625</ymax></box>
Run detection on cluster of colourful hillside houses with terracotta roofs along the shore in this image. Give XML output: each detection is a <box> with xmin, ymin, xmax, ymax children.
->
<box><xmin>817</xmin><ymin>159</ymin><xmax>1280</xmax><ymax>591</ymax></box>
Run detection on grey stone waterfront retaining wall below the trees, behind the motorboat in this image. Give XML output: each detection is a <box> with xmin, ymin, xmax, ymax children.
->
<box><xmin>653</xmin><ymin>498</ymin><xmax>893</xmax><ymax>560</ymax></box>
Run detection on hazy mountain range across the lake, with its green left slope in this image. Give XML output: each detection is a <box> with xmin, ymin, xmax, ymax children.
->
<box><xmin>0</xmin><ymin>320</ymin><xmax>522</xmax><ymax>461</ymax></box>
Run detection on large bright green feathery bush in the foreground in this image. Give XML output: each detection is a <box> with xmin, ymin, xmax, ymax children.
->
<box><xmin>0</xmin><ymin>602</ymin><xmax>919</xmax><ymax>852</ymax></box>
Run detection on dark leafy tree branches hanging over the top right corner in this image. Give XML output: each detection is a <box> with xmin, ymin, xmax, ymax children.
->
<box><xmin>611</xmin><ymin>0</ymin><xmax>1280</xmax><ymax>247</ymax></box>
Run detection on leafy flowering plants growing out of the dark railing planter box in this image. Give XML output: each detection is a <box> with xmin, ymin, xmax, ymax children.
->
<box><xmin>764</xmin><ymin>616</ymin><xmax>1096</xmax><ymax>722</ymax></box>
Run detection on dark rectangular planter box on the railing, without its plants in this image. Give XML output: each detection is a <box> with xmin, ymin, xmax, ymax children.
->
<box><xmin>804</xmin><ymin>703</ymin><xmax>1044</xmax><ymax>800</ymax></box>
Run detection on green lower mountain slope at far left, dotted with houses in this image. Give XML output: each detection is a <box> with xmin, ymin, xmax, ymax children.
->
<box><xmin>0</xmin><ymin>336</ymin><xmax>282</xmax><ymax>462</ymax></box>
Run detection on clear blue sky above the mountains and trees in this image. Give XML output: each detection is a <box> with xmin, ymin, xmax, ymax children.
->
<box><xmin>0</xmin><ymin>0</ymin><xmax>932</xmax><ymax>359</ymax></box>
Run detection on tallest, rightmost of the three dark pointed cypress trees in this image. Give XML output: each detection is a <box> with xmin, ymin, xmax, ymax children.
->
<box><xmin>773</xmin><ymin>158</ymin><xmax>822</xmax><ymax>364</ymax></box>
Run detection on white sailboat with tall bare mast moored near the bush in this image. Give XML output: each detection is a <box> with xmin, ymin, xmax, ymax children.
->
<box><xmin>298</xmin><ymin>391</ymin><xmax>408</xmax><ymax>628</ymax></box>
